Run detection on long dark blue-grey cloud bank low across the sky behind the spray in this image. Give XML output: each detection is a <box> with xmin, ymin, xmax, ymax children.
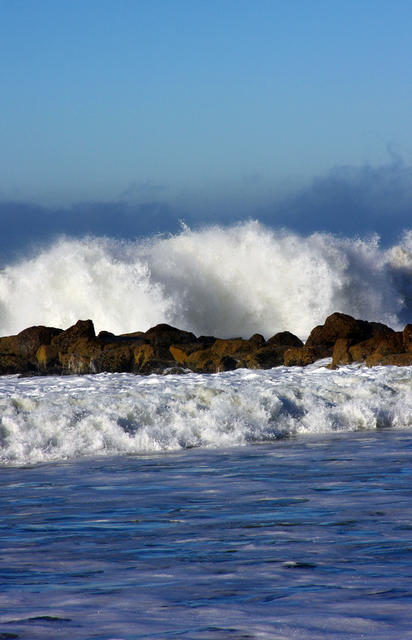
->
<box><xmin>0</xmin><ymin>156</ymin><xmax>412</xmax><ymax>266</ymax></box>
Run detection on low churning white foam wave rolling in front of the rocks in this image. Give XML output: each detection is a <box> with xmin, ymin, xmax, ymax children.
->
<box><xmin>0</xmin><ymin>365</ymin><xmax>412</xmax><ymax>465</ymax></box>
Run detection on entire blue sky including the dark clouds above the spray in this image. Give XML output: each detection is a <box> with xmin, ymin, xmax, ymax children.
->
<box><xmin>0</xmin><ymin>0</ymin><xmax>412</xmax><ymax>258</ymax></box>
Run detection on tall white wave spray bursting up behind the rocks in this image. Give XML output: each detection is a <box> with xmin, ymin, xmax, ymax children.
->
<box><xmin>0</xmin><ymin>222</ymin><xmax>412</xmax><ymax>337</ymax></box>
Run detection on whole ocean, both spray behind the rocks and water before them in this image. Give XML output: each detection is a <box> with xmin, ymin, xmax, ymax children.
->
<box><xmin>0</xmin><ymin>222</ymin><xmax>412</xmax><ymax>640</ymax></box>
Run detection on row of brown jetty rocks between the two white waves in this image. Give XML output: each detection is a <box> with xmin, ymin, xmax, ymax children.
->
<box><xmin>0</xmin><ymin>312</ymin><xmax>412</xmax><ymax>375</ymax></box>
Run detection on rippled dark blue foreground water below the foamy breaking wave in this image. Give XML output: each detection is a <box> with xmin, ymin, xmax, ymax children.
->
<box><xmin>0</xmin><ymin>430</ymin><xmax>412</xmax><ymax>640</ymax></box>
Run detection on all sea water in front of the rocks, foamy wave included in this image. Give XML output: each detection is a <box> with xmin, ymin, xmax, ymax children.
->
<box><xmin>0</xmin><ymin>362</ymin><xmax>412</xmax><ymax>640</ymax></box>
